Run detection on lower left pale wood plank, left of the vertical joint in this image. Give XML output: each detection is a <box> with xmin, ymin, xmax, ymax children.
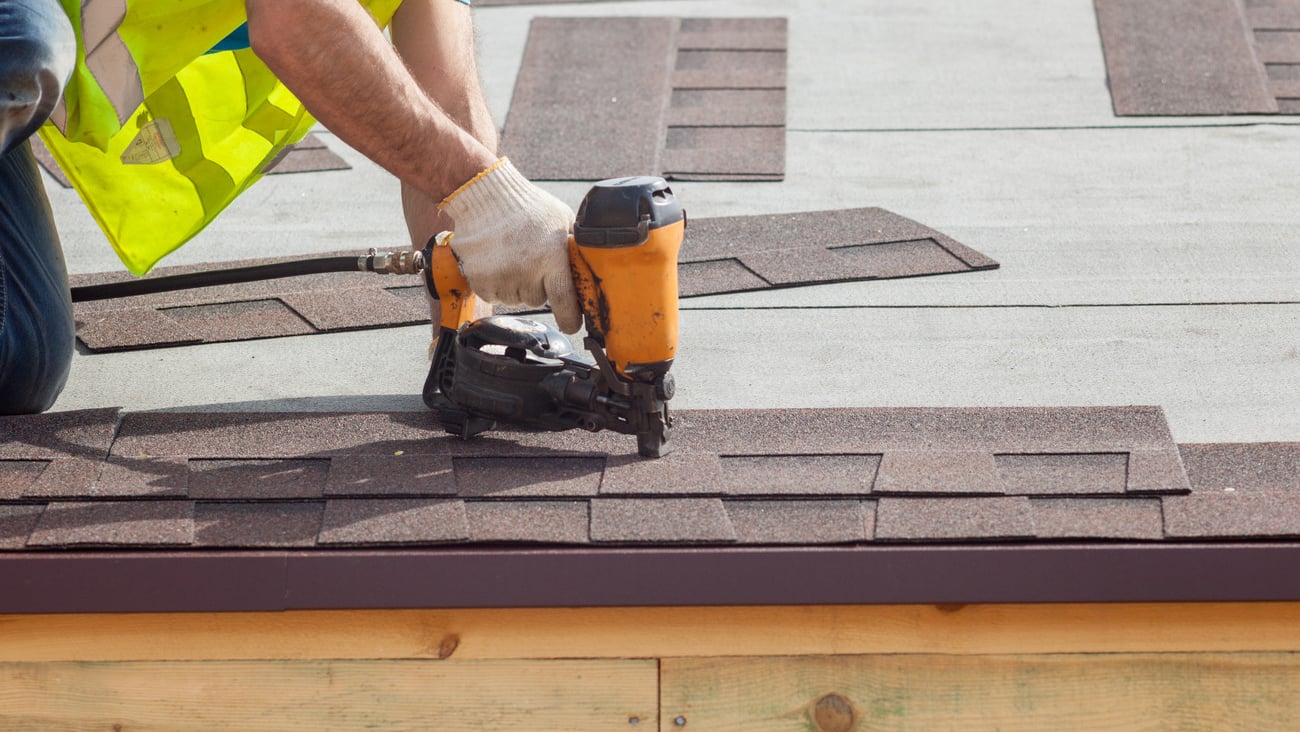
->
<box><xmin>0</xmin><ymin>660</ymin><xmax>658</xmax><ymax>731</ymax></box>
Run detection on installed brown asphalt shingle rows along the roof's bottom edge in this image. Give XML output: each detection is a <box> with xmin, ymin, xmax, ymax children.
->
<box><xmin>0</xmin><ymin>407</ymin><xmax>1258</xmax><ymax>551</ymax></box>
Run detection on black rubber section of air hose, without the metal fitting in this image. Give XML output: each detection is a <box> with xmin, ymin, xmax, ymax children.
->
<box><xmin>72</xmin><ymin>255</ymin><xmax>374</xmax><ymax>303</ymax></box>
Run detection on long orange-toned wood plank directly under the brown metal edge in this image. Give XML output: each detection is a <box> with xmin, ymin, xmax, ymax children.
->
<box><xmin>0</xmin><ymin>602</ymin><xmax>1300</xmax><ymax>662</ymax></box>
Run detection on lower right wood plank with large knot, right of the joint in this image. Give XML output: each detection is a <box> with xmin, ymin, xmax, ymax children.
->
<box><xmin>660</xmin><ymin>654</ymin><xmax>1300</xmax><ymax>732</ymax></box>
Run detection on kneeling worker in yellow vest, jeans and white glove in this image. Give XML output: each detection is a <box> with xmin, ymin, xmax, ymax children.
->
<box><xmin>0</xmin><ymin>0</ymin><xmax>581</xmax><ymax>413</ymax></box>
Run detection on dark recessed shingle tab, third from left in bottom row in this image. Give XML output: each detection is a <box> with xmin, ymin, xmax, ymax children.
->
<box><xmin>194</xmin><ymin>501</ymin><xmax>325</xmax><ymax>547</ymax></box>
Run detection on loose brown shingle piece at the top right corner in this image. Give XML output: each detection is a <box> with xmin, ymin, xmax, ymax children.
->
<box><xmin>1095</xmin><ymin>0</ymin><xmax>1300</xmax><ymax>116</ymax></box>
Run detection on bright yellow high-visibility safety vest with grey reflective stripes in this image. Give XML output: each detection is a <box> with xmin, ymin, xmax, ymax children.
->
<box><xmin>40</xmin><ymin>0</ymin><xmax>402</xmax><ymax>274</ymax></box>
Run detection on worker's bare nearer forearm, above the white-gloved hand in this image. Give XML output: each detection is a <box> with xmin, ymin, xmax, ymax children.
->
<box><xmin>247</xmin><ymin>0</ymin><xmax>497</xmax><ymax>200</ymax></box>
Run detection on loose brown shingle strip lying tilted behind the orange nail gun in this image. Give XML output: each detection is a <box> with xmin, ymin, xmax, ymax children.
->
<box><xmin>72</xmin><ymin>208</ymin><xmax>997</xmax><ymax>351</ymax></box>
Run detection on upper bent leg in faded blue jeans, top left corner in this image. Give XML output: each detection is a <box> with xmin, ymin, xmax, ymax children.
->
<box><xmin>0</xmin><ymin>0</ymin><xmax>77</xmax><ymax>155</ymax></box>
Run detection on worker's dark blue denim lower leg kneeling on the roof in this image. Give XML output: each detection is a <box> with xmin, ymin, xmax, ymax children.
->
<box><xmin>0</xmin><ymin>144</ymin><xmax>75</xmax><ymax>415</ymax></box>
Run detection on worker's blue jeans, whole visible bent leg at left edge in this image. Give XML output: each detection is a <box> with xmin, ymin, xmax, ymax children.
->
<box><xmin>0</xmin><ymin>0</ymin><xmax>77</xmax><ymax>413</ymax></box>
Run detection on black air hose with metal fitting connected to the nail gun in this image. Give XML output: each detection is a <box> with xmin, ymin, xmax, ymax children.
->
<box><xmin>72</xmin><ymin>250</ymin><xmax>424</xmax><ymax>303</ymax></box>
